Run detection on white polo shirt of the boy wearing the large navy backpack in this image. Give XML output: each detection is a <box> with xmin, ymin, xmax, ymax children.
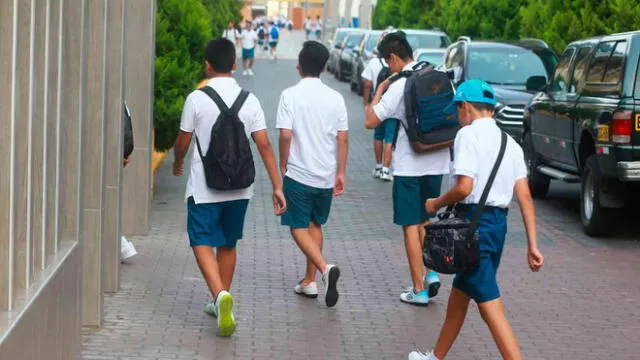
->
<box><xmin>373</xmin><ymin>62</ymin><xmax>451</xmax><ymax>176</ymax></box>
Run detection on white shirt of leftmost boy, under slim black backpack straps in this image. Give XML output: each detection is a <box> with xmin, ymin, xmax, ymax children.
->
<box><xmin>180</xmin><ymin>78</ymin><xmax>267</xmax><ymax>204</ymax></box>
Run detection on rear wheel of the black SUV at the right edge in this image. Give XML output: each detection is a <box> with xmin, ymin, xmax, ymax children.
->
<box><xmin>580</xmin><ymin>155</ymin><xmax>611</xmax><ymax>237</ymax></box>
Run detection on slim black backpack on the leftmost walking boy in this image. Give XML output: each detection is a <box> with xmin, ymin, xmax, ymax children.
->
<box><xmin>196</xmin><ymin>86</ymin><xmax>256</xmax><ymax>190</ymax></box>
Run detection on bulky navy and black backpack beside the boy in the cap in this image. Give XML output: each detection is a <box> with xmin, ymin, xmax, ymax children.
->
<box><xmin>400</xmin><ymin>62</ymin><xmax>460</xmax><ymax>153</ymax></box>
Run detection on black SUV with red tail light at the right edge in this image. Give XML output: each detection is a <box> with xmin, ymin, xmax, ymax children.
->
<box><xmin>523</xmin><ymin>31</ymin><xmax>640</xmax><ymax>236</ymax></box>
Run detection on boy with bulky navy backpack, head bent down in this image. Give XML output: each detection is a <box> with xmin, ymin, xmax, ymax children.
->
<box><xmin>365</xmin><ymin>32</ymin><xmax>450</xmax><ymax>306</ymax></box>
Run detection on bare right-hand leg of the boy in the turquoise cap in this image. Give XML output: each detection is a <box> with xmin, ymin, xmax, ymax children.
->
<box><xmin>478</xmin><ymin>298</ymin><xmax>522</xmax><ymax>360</ymax></box>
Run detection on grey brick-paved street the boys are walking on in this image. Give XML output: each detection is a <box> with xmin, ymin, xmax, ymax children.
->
<box><xmin>83</xmin><ymin>32</ymin><xmax>640</xmax><ymax>360</ymax></box>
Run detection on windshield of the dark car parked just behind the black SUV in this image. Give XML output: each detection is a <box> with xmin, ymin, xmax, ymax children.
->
<box><xmin>466</xmin><ymin>47</ymin><xmax>548</xmax><ymax>86</ymax></box>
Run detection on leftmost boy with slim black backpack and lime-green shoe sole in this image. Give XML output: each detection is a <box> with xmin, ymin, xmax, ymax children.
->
<box><xmin>173</xmin><ymin>38</ymin><xmax>286</xmax><ymax>336</ymax></box>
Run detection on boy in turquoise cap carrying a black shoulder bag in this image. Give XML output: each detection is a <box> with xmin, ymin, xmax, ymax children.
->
<box><xmin>409</xmin><ymin>80</ymin><xmax>544</xmax><ymax>360</ymax></box>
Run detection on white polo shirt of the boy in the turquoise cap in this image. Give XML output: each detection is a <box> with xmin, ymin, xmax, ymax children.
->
<box><xmin>452</xmin><ymin>118</ymin><xmax>527</xmax><ymax>208</ymax></box>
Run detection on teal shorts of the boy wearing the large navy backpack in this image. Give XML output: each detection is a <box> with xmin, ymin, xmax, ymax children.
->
<box><xmin>393</xmin><ymin>175</ymin><xmax>442</xmax><ymax>226</ymax></box>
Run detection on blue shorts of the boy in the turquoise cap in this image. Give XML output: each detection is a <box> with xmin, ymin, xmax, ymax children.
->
<box><xmin>453</xmin><ymin>208</ymin><xmax>507</xmax><ymax>304</ymax></box>
